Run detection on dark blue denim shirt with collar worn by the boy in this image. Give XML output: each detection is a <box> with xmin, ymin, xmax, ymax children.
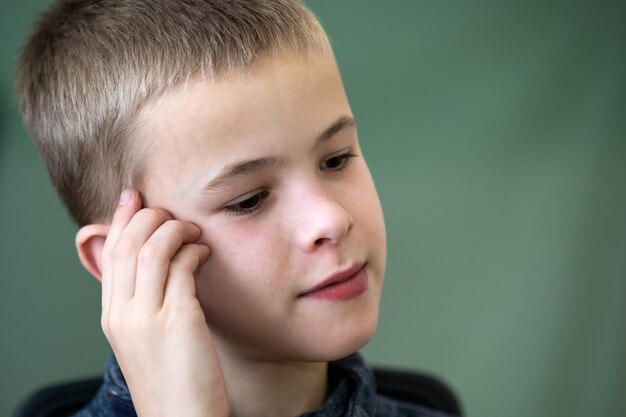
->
<box><xmin>74</xmin><ymin>353</ymin><xmax>445</xmax><ymax>417</ymax></box>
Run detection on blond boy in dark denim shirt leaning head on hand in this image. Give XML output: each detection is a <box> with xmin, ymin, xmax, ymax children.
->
<box><xmin>19</xmin><ymin>0</ymin><xmax>450</xmax><ymax>417</ymax></box>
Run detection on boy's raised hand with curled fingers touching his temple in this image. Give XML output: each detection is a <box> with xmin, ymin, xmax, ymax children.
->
<box><xmin>102</xmin><ymin>191</ymin><xmax>228</xmax><ymax>417</ymax></box>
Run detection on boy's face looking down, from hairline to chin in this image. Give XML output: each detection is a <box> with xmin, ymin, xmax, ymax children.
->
<box><xmin>138</xmin><ymin>52</ymin><xmax>386</xmax><ymax>361</ymax></box>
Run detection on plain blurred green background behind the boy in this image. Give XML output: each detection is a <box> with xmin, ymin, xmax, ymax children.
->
<box><xmin>0</xmin><ymin>0</ymin><xmax>626</xmax><ymax>417</ymax></box>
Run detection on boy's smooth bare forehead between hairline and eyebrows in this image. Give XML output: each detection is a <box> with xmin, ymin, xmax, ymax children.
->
<box><xmin>136</xmin><ymin>49</ymin><xmax>350</xmax><ymax>186</ymax></box>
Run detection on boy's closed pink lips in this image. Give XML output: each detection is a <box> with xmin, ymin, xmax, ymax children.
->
<box><xmin>299</xmin><ymin>263</ymin><xmax>369</xmax><ymax>300</ymax></box>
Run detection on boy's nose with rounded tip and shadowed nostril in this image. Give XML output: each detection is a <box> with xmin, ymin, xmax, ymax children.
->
<box><xmin>296</xmin><ymin>185</ymin><xmax>354</xmax><ymax>252</ymax></box>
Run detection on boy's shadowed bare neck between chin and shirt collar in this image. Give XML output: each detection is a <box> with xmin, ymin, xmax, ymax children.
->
<box><xmin>218</xmin><ymin>342</ymin><xmax>328</xmax><ymax>417</ymax></box>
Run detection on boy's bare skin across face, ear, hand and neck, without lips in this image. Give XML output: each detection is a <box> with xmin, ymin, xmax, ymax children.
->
<box><xmin>77</xmin><ymin>51</ymin><xmax>385</xmax><ymax>416</ymax></box>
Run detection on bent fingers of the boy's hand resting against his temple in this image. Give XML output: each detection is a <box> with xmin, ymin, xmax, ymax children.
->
<box><xmin>102</xmin><ymin>190</ymin><xmax>209</xmax><ymax>312</ymax></box>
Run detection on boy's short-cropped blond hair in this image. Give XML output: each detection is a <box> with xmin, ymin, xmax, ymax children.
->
<box><xmin>17</xmin><ymin>0</ymin><xmax>328</xmax><ymax>226</ymax></box>
